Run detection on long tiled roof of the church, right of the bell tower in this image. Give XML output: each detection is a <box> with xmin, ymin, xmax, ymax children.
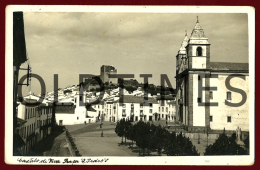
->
<box><xmin>208</xmin><ymin>62</ymin><xmax>249</xmax><ymax>70</ymax></box>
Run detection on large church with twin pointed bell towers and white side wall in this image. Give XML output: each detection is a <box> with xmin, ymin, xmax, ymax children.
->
<box><xmin>176</xmin><ymin>20</ymin><xmax>249</xmax><ymax>131</ymax></box>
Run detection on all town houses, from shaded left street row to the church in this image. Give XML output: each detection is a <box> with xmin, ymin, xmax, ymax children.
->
<box><xmin>17</xmin><ymin>85</ymin><xmax>175</xmax><ymax>155</ymax></box>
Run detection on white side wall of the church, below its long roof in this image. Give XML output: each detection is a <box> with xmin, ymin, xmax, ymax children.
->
<box><xmin>210</xmin><ymin>73</ymin><xmax>249</xmax><ymax>131</ymax></box>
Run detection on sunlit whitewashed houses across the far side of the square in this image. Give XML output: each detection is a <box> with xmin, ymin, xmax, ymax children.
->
<box><xmin>55</xmin><ymin>85</ymin><xmax>175</xmax><ymax>125</ymax></box>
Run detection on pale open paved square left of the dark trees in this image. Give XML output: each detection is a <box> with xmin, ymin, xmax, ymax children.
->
<box><xmin>66</xmin><ymin>122</ymin><xmax>139</xmax><ymax>156</ymax></box>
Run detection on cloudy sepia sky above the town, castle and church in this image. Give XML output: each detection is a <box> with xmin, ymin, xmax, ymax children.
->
<box><xmin>19</xmin><ymin>12</ymin><xmax>248</xmax><ymax>95</ymax></box>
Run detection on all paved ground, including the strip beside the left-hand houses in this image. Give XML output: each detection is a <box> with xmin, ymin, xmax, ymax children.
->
<box><xmin>34</xmin><ymin>121</ymin><xmax>215</xmax><ymax>156</ymax></box>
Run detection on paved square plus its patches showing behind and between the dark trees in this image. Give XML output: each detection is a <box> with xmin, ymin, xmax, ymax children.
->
<box><xmin>66</xmin><ymin>121</ymin><xmax>215</xmax><ymax>156</ymax></box>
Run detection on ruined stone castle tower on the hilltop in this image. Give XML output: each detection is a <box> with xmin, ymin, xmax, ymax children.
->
<box><xmin>100</xmin><ymin>65</ymin><xmax>118</xmax><ymax>84</ymax></box>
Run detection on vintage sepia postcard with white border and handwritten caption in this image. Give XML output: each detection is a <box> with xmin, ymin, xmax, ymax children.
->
<box><xmin>5</xmin><ymin>5</ymin><xmax>255</xmax><ymax>165</ymax></box>
